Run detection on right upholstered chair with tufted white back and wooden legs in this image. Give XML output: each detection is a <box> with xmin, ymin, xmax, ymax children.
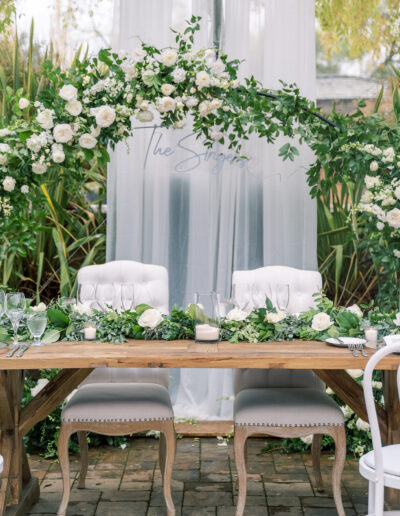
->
<box><xmin>232</xmin><ymin>266</ymin><xmax>346</xmax><ymax>515</ymax></box>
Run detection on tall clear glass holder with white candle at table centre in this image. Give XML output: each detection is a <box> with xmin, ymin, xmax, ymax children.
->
<box><xmin>194</xmin><ymin>292</ymin><xmax>220</xmax><ymax>344</ymax></box>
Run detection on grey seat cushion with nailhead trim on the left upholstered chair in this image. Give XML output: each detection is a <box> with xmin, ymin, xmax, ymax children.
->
<box><xmin>62</xmin><ymin>383</ymin><xmax>173</xmax><ymax>422</ymax></box>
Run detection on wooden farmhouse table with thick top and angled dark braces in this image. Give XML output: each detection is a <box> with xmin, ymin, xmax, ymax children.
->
<box><xmin>0</xmin><ymin>340</ymin><xmax>400</xmax><ymax>515</ymax></box>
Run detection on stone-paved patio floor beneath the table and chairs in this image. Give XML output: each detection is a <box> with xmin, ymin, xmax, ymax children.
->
<box><xmin>30</xmin><ymin>437</ymin><xmax>367</xmax><ymax>516</ymax></box>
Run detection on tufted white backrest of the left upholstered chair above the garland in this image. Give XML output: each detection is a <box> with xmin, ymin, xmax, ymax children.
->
<box><xmin>78</xmin><ymin>260</ymin><xmax>169</xmax><ymax>314</ymax></box>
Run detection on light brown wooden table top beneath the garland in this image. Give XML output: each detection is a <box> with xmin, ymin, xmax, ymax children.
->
<box><xmin>0</xmin><ymin>340</ymin><xmax>400</xmax><ymax>370</ymax></box>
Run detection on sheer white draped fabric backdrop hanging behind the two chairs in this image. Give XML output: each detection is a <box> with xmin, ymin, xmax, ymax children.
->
<box><xmin>107</xmin><ymin>0</ymin><xmax>317</xmax><ymax>420</ymax></box>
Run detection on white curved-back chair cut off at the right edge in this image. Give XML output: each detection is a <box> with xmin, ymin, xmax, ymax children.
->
<box><xmin>359</xmin><ymin>343</ymin><xmax>400</xmax><ymax>516</ymax></box>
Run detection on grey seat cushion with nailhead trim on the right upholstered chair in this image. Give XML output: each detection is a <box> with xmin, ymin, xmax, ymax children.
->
<box><xmin>235</xmin><ymin>388</ymin><xmax>344</xmax><ymax>427</ymax></box>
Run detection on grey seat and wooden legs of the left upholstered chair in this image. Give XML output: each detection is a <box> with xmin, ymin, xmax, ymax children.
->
<box><xmin>57</xmin><ymin>382</ymin><xmax>176</xmax><ymax>516</ymax></box>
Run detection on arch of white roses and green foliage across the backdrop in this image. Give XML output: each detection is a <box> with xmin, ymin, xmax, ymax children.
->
<box><xmin>0</xmin><ymin>16</ymin><xmax>400</xmax><ymax>302</ymax></box>
